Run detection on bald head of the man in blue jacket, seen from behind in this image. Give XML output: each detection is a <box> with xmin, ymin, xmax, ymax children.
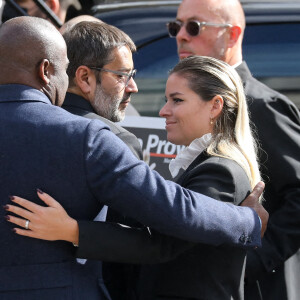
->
<box><xmin>0</xmin><ymin>17</ymin><xmax>68</xmax><ymax>104</ymax></box>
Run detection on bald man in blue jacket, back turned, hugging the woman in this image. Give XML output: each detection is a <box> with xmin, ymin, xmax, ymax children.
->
<box><xmin>0</xmin><ymin>17</ymin><xmax>267</xmax><ymax>300</ymax></box>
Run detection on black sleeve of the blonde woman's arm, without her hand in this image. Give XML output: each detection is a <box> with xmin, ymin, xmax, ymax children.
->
<box><xmin>76</xmin><ymin>221</ymin><xmax>194</xmax><ymax>264</ymax></box>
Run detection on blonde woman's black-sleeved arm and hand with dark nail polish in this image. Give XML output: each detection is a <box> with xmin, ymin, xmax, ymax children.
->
<box><xmin>6</xmin><ymin>190</ymin><xmax>193</xmax><ymax>264</ymax></box>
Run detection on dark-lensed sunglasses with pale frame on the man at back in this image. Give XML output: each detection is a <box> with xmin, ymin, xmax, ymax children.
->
<box><xmin>167</xmin><ymin>21</ymin><xmax>232</xmax><ymax>37</ymax></box>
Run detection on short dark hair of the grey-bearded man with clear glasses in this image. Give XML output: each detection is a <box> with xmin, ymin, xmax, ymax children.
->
<box><xmin>63</xmin><ymin>21</ymin><xmax>136</xmax><ymax>86</ymax></box>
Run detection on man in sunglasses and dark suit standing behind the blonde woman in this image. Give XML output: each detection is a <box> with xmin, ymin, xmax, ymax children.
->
<box><xmin>167</xmin><ymin>0</ymin><xmax>300</xmax><ymax>300</ymax></box>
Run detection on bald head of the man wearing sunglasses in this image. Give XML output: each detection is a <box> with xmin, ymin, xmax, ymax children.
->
<box><xmin>176</xmin><ymin>0</ymin><xmax>245</xmax><ymax>65</ymax></box>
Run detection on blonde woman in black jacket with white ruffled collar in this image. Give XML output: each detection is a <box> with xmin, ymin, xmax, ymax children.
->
<box><xmin>5</xmin><ymin>56</ymin><xmax>260</xmax><ymax>300</ymax></box>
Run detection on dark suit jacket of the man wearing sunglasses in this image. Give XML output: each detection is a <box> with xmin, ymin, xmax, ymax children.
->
<box><xmin>236</xmin><ymin>62</ymin><xmax>300</xmax><ymax>300</ymax></box>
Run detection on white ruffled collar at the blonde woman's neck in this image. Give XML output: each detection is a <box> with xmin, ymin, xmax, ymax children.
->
<box><xmin>169</xmin><ymin>133</ymin><xmax>211</xmax><ymax>178</ymax></box>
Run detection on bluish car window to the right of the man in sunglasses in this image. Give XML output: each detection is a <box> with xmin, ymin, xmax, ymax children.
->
<box><xmin>243</xmin><ymin>23</ymin><xmax>300</xmax><ymax>108</ymax></box>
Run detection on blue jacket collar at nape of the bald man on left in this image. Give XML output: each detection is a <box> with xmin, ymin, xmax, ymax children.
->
<box><xmin>0</xmin><ymin>84</ymin><xmax>52</xmax><ymax>104</ymax></box>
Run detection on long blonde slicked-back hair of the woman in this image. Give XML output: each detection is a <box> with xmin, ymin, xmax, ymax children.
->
<box><xmin>170</xmin><ymin>56</ymin><xmax>261</xmax><ymax>188</ymax></box>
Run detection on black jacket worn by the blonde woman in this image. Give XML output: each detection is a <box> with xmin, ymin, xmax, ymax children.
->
<box><xmin>79</xmin><ymin>152</ymin><xmax>251</xmax><ymax>300</ymax></box>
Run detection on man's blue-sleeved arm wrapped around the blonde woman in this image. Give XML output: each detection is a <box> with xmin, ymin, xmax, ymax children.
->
<box><xmin>4</xmin><ymin>123</ymin><xmax>267</xmax><ymax>247</ymax></box>
